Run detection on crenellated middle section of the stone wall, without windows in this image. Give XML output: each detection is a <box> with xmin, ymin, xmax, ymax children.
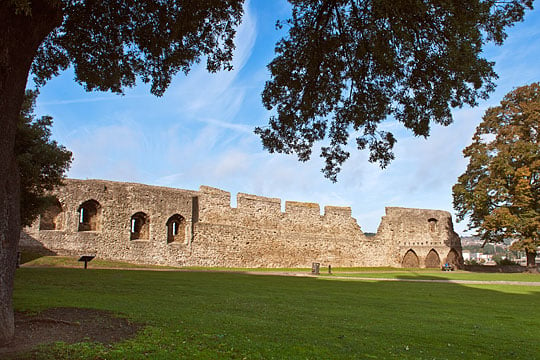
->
<box><xmin>193</xmin><ymin>186</ymin><xmax>386</xmax><ymax>267</ymax></box>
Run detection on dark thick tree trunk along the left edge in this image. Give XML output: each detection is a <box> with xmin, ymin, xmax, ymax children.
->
<box><xmin>0</xmin><ymin>0</ymin><xmax>62</xmax><ymax>346</ymax></box>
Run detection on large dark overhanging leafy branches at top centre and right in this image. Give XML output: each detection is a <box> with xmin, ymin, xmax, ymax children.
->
<box><xmin>256</xmin><ymin>0</ymin><xmax>532</xmax><ymax>181</ymax></box>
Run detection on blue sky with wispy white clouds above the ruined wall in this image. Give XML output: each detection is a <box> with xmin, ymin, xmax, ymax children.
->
<box><xmin>36</xmin><ymin>0</ymin><xmax>540</xmax><ymax>233</ymax></box>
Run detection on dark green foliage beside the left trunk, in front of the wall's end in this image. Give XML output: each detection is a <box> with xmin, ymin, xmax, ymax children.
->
<box><xmin>15</xmin><ymin>90</ymin><xmax>72</xmax><ymax>226</ymax></box>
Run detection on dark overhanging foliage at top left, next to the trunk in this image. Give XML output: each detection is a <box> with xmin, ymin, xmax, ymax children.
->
<box><xmin>31</xmin><ymin>0</ymin><xmax>243</xmax><ymax>95</ymax></box>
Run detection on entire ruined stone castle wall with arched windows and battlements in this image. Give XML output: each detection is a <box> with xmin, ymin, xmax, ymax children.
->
<box><xmin>20</xmin><ymin>179</ymin><xmax>461</xmax><ymax>267</ymax></box>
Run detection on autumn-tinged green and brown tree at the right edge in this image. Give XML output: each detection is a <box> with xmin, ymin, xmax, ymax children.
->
<box><xmin>453</xmin><ymin>83</ymin><xmax>540</xmax><ymax>265</ymax></box>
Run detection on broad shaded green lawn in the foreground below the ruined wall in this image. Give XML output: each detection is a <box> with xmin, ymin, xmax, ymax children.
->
<box><xmin>10</xmin><ymin>268</ymin><xmax>540</xmax><ymax>359</ymax></box>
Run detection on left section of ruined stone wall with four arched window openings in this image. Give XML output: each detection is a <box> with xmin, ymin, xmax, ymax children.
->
<box><xmin>20</xmin><ymin>179</ymin><xmax>197</xmax><ymax>265</ymax></box>
